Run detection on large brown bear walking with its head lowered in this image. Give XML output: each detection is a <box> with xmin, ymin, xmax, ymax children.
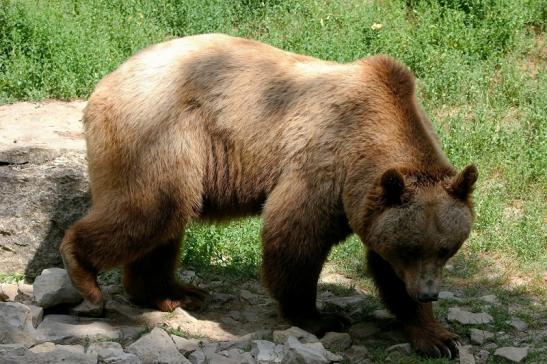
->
<box><xmin>60</xmin><ymin>34</ymin><xmax>477</xmax><ymax>355</ymax></box>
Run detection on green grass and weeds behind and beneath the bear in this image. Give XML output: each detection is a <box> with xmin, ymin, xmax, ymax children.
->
<box><xmin>0</xmin><ymin>0</ymin><xmax>547</xmax><ymax>362</ymax></box>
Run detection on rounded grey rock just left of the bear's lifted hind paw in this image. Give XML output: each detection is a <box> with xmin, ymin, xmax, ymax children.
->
<box><xmin>33</xmin><ymin>268</ymin><xmax>82</xmax><ymax>308</ymax></box>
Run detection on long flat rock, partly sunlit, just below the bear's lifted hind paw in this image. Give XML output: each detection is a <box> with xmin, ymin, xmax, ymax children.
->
<box><xmin>36</xmin><ymin>315</ymin><xmax>124</xmax><ymax>344</ymax></box>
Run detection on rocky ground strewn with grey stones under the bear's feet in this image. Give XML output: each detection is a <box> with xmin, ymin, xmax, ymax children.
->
<box><xmin>0</xmin><ymin>268</ymin><xmax>547</xmax><ymax>364</ymax></box>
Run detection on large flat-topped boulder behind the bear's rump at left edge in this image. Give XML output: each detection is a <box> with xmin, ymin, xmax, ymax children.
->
<box><xmin>0</xmin><ymin>101</ymin><xmax>90</xmax><ymax>278</ymax></box>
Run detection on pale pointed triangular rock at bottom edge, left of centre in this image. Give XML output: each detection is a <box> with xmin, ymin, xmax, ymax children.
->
<box><xmin>127</xmin><ymin>327</ymin><xmax>188</xmax><ymax>364</ymax></box>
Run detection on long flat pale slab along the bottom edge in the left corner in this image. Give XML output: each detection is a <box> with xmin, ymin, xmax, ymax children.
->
<box><xmin>0</xmin><ymin>343</ymin><xmax>97</xmax><ymax>364</ymax></box>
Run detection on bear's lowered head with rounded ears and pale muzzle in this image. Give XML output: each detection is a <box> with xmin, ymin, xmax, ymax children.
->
<box><xmin>363</xmin><ymin>165</ymin><xmax>478</xmax><ymax>302</ymax></box>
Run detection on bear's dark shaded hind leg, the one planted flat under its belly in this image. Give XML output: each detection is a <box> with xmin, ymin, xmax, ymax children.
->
<box><xmin>123</xmin><ymin>239</ymin><xmax>207</xmax><ymax>311</ymax></box>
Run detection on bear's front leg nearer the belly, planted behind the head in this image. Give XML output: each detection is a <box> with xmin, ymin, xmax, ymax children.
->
<box><xmin>262</xmin><ymin>176</ymin><xmax>356</xmax><ymax>336</ymax></box>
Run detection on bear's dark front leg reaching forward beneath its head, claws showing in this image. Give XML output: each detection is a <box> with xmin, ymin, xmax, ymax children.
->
<box><xmin>367</xmin><ymin>251</ymin><xmax>459</xmax><ymax>358</ymax></box>
